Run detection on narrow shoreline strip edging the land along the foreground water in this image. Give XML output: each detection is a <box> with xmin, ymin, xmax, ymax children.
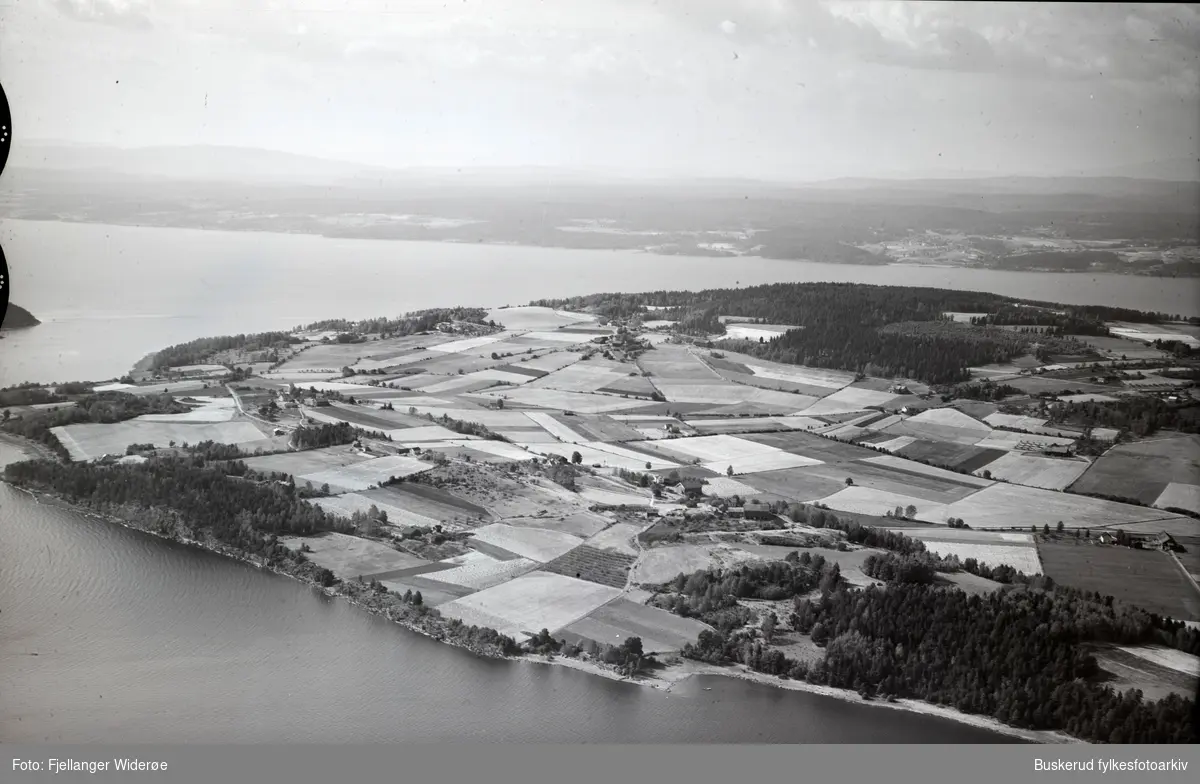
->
<box><xmin>0</xmin><ymin>433</ymin><xmax>1086</xmax><ymax>743</ymax></box>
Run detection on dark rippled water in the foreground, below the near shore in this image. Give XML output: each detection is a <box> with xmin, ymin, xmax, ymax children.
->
<box><xmin>0</xmin><ymin>443</ymin><xmax>1007</xmax><ymax>743</ymax></box>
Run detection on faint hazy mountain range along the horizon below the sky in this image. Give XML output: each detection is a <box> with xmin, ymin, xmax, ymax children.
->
<box><xmin>8</xmin><ymin>142</ymin><xmax>1200</xmax><ymax>188</ymax></box>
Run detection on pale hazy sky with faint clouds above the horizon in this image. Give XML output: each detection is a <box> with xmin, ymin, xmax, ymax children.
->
<box><xmin>0</xmin><ymin>0</ymin><xmax>1200</xmax><ymax>180</ymax></box>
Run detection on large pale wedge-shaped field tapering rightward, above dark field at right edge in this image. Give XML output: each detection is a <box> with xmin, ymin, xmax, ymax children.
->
<box><xmin>930</xmin><ymin>481</ymin><xmax>1163</xmax><ymax>528</ymax></box>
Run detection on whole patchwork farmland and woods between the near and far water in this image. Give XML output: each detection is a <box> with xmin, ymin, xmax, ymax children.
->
<box><xmin>0</xmin><ymin>283</ymin><xmax>1200</xmax><ymax>743</ymax></box>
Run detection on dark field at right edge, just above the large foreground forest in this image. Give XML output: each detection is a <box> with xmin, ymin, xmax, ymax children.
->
<box><xmin>1038</xmin><ymin>540</ymin><xmax>1200</xmax><ymax>621</ymax></box>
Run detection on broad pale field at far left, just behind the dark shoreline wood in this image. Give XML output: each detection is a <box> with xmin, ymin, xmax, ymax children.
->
<box><xmin>50</xmin><ymin>419</ymin><xmax>265</xmax><ymax>460</ymax></box>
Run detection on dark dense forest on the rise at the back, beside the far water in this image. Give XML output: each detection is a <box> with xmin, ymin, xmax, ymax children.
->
<box><xmin>533</xmin><ymin>283</ymin><xmax>1166</xmax><ymax>384</ymax></box>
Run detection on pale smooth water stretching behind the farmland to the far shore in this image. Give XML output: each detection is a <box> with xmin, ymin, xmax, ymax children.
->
<box><xmin>0</xmin><ymin>220</ymin><xmax>1200</xmax><ymax>385</ymax></box>
